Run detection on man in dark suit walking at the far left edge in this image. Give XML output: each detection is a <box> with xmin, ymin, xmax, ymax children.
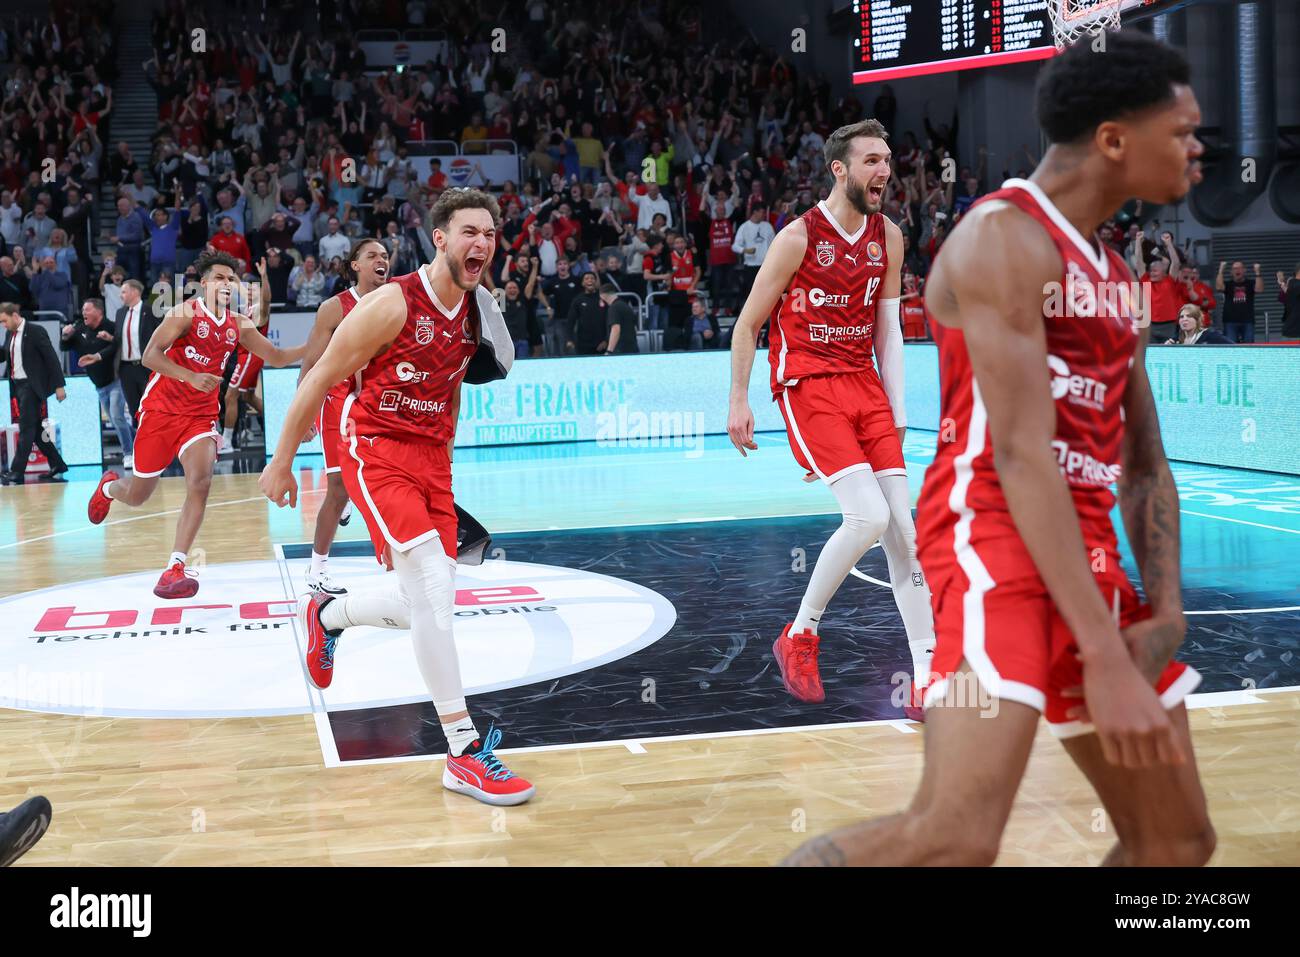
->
<box><xmin>0</xmin><ymin>303</ymin><xmax>68</xmax><ymax>485</ymax></box>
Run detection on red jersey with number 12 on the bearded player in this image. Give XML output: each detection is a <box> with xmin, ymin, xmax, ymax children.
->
<box><xmin>767</xmin><ymin>200</ymin><xmax>889</xmax><ymax>394</ymax></box>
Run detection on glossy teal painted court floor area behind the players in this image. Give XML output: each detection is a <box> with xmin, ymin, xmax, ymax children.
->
<box><xmin>0</xmin><ymin>430</ymin><xmax>1300</xmax><ymax>608</ymax></box>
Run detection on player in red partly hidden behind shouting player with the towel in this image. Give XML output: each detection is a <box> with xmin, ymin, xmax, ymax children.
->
<box><xmin>298</xmin><ymin>237</ymin><xmax>389</xmax><ymax>594</ymax></box>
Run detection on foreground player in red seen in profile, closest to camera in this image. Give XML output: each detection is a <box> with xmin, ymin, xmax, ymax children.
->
<box><xmin>790</xmin><ymin>31</ymin><xmax>1214</xmax><ymax>866</ymax></box>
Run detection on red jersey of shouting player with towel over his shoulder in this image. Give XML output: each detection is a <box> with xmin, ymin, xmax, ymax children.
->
<box><xmin>342</xmin><ymin>267</ymin><xmax>480</xmax><ymax>442</ymax></box>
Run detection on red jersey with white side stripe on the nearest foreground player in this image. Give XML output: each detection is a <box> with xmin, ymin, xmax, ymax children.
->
<box><xmin>917</xmin><ymin>179</ymin><xmax>1139</xmax><ymax>583</ymax></box>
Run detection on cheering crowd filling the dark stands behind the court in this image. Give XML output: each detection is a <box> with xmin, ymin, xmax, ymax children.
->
<box><xmin>0</xmin><ymin>0</ymin><xmax>1286</xmax><ymax>355</ymax></box>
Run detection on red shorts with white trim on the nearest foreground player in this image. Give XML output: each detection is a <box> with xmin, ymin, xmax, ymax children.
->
<box><xmin>926</xmin><ymin>570</ymin><xmax>1201</xmax><ymax>737</ymax></box>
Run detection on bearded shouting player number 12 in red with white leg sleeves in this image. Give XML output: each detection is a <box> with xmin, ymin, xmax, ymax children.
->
<box><xmin>727</xmin><ymin>120</ymin><xmax>935</xmax><ymax>718</ymax></box>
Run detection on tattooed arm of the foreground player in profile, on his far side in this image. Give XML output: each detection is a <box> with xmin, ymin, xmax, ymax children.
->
<box><xmin>1119</xmin><ymin>328</ymin><xmax>1187</xmax><ymax>681</ymax></box>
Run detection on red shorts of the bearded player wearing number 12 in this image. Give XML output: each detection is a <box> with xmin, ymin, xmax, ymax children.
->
<box><xmin>776</xmin><ymin>371</ymin><xmax>907</xmax><ymax>485</ymax></box>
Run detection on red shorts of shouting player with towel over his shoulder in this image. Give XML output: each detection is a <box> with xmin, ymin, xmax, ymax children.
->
<box><xmin>341</xmin><ymin>436</ymin><xmax>456</xmax><ymax>564</ymax></box>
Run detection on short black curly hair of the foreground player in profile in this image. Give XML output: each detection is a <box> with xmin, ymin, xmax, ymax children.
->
<box><xmin>1035</xmin><ymin>30</ymin><xmax>1191</xmax><ymax>144</ymax></box>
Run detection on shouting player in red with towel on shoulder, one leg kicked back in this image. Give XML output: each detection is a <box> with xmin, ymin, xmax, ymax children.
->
<box><xmin>260</xmin><ymin>190</ymin><xmax>533</xmax><ymax>805</ymax></box>
